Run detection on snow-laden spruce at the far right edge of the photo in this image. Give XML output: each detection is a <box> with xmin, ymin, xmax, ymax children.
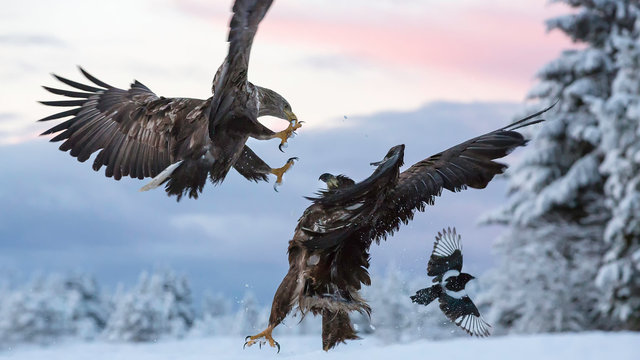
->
<box><xmin>592</xmin><ymin>7</ymin><xmax>640</xmax><ymax>330</ymax></box>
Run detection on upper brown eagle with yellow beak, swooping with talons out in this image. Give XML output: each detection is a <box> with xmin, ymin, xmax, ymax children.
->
<box><xmin>39</xmin><ymin>0</ymin><xmax>301</xmax><ymax>200</ymax></box>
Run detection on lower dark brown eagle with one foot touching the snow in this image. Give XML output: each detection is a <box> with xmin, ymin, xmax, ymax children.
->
<box><xmin>245</xmin><ymin>107</ymin><xmax>550</xmax><ymax>350</ymax></box>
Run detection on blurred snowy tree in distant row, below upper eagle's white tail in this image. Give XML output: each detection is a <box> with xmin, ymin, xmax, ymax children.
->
<box><xmin>105</xmin><ymin>271</ymin><xmax>194</xmax><ymax>341</ymax></box>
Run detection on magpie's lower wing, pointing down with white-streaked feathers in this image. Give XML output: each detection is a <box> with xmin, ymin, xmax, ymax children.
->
<box><xmin>440</xmin><ymin>293</ymin><xmax>491</xmax><ymax>337</ymax></box>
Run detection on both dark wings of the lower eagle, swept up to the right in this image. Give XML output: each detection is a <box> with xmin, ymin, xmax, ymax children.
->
<box><xmin>305</xmin><ymin>107</ymin><xmax>550</xmax><ymax>249</ymax></box>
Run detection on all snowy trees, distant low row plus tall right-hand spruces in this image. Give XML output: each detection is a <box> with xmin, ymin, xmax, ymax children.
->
<box><xmin>0</xmin><ymin>0</ymin><xmax>640</xmax><ymax>354</ymax></box>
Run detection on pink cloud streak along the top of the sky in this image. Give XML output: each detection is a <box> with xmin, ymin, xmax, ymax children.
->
<box><xmin>179</xmin><ymin>0</ymin><xmax>571</xmax><ymax>87</ymax></box>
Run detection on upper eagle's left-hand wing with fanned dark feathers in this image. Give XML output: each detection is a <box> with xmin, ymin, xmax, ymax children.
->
<box><xmin>40</xmin><ymin>69</ymin><xmax>208</xmax><ymax>180</ymax></box>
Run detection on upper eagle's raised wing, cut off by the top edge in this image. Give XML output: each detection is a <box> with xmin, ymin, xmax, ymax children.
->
<box><xmin>210</xmin><ymin>0</ymin><xmax>273</xmax><ymax>131</ymax></box>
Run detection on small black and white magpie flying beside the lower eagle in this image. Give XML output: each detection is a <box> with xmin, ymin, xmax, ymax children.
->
<box><xmin>411</xmin><ymin>228</ymin><xmax>491</xmax><ymax>337</ymax></box>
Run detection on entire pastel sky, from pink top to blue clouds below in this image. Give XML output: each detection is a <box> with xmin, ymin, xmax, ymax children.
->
<box><xmin>0</xmin><ymin>0</ymin><xmax>573</xmax><ymax>300</ymax></box>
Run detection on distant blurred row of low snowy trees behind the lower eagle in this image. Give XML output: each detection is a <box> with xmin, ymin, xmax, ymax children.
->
<box><xmin>0</xmin><ymin>269</ymin><xmax>464</xmax><ymax>347</ymax></box>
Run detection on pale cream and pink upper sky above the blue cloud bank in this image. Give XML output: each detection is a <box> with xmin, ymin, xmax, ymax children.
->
<box><xmin>0</xmin><ymin>0</ymin><xmax>570</xmax><ymax>144</ymax></box>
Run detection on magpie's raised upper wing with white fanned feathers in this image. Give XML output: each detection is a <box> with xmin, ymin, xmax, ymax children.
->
<box><xmin>427</xmin><ymin>227</ymin><xmax>462</xmax><ymax>281</ymax></box>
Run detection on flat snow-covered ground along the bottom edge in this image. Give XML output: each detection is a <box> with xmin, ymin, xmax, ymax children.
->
<box><xmin>0</xmin><ymin>332</ymin><xmax>640</xmax><ymax>360</ymax></box>
